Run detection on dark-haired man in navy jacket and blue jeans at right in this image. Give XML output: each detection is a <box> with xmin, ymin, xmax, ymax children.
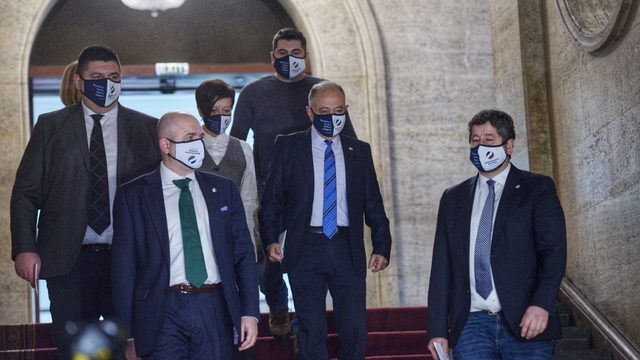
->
<box><xmin>427</xmin><ymin>110</ymin><xmax>566</xmax><ymax>360</ymax></box>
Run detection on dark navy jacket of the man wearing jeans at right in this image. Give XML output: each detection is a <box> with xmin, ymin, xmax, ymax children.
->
<box><xmin>427</xmin><ymin>165</ymin><xmax>567</xmax><ymax>347</ymax></box>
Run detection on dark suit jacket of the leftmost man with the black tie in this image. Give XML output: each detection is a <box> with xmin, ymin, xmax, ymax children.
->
<box><xmin>11</xmin><ymin>103</ymin><xmax>160</xmax><ymax>278</ymax></box>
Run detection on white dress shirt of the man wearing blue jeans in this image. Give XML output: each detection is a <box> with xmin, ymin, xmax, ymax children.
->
<box><xmin>469</xmin><ymin>164</ymin><xmax>511</xmax><ymax>312</ymax></box>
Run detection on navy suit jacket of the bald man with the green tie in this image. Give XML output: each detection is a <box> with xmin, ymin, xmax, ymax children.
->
<box><xmin>111</xmin><ymin>169</ymin><xmax>259</xmax><ymax>356</ymax></box>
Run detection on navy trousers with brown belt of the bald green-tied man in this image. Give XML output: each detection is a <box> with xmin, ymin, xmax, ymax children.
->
<box><xmin>145</xmin><ymin>290</ymin><xmax>233</xmax><ymax>360</ymax></box>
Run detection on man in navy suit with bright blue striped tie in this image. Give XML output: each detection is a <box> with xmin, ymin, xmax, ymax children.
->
<box><xmin>260</xmin><ymin>81</ymin><xmax>391</xmax><ymax>359</ymax></box>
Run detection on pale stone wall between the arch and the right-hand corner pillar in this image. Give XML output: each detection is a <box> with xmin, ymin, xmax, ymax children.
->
<box><xmin>370</xmin><ymin>0</ymin><xmax>498</xmax><ymax>306</ymax></box>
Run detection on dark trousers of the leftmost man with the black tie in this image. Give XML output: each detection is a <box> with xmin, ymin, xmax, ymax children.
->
<box><xmin>47</xmin><ymin>246</ymin><xmax>113</xmax><ymax>358</ymax></box>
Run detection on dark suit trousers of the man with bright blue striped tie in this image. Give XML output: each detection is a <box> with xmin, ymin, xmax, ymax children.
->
<box><xmin>285</xmin><ymin>229</ymin><xmax>367</xmax><ymax>360</ymax></box>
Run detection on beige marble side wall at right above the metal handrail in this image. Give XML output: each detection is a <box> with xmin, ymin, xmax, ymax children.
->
<box><xmin>492</xmin><ymin>0</ymin><xmax>640</xmax><ymax>344</ymax></box>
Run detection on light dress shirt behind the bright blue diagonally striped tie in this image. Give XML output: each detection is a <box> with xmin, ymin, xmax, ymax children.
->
<box><xmin>309</xmin><ymin>126</ymin><xmax>349</xmax><ymax>226</ymax></box>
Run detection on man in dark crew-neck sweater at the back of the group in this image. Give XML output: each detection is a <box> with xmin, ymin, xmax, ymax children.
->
<box><xmin>230</xmin><ymin>28</ymin><xmax>356</xmax><ymax>338</ymax></box>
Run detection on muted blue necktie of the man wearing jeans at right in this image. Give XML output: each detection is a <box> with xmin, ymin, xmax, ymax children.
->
<box><xmin>474</xmin><ymin>180</ymin><xmax>496</xmax><ymax>299</ymax></box>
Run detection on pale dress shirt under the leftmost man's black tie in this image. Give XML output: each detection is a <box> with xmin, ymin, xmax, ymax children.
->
<box><xmin>82</xmin><ymin>102</ymin><xmax>118</xmax><ymax>244</ymax></box>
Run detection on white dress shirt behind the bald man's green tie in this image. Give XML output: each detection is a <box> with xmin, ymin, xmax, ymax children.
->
<box><xmin>160</xmin><ymin>163</ymin><xmax>221</xmax><ymax>286</ymax></box>
